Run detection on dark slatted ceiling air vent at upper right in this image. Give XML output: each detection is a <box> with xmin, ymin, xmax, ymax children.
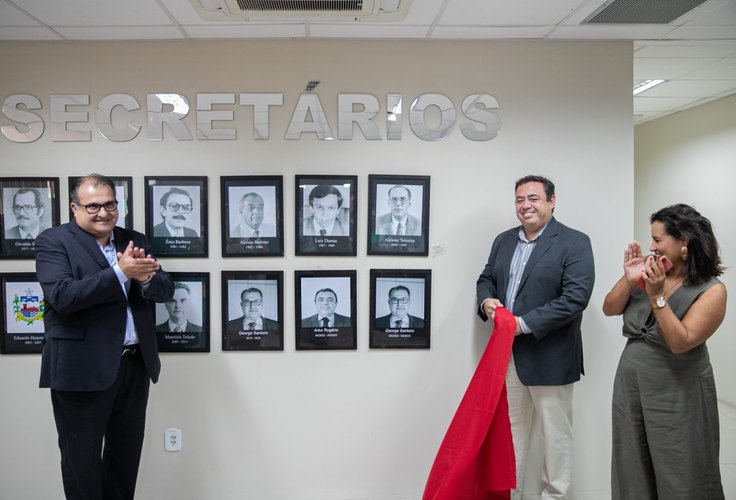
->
<box><xmin>582</xmin><ymin>0</ymin><xmax>706</xmax><ymax>24</ymax></box>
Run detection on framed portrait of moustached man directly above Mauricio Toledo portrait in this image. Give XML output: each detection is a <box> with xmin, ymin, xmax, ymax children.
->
<box><xmin>145</xmin><ymin>177</ymin><xmax>208</xmax><ymax>257</ymax></box>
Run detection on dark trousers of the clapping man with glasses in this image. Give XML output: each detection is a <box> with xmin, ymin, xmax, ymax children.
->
<box><xmin>51</xmin><ymin>354</ymin><xmax>150</xmax><ymax>500</ymax></box>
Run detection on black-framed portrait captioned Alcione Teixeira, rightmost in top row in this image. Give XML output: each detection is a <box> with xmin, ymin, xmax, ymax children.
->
<box><xmin>368</xmin><ymin>175</ymin><xmax>429</xmax><ymax>256</ymax></box>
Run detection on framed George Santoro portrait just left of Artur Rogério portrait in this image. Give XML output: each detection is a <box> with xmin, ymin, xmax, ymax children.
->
<box><xmin>222</xmin><ymin>271</ymin><xmax>284</xmax><ymax>351</ymax></box>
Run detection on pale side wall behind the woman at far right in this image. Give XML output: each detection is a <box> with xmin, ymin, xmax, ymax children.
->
<box><xmin>636</xmin><ymin>95</ymin><xmax>736</xmax><ymax>406</ymax></box>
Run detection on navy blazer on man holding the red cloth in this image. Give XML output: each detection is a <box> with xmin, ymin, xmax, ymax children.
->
<box><xmin>476</xmin><ymin>217</ymin><xmax>595</xmax><ymax>385</ymax></box>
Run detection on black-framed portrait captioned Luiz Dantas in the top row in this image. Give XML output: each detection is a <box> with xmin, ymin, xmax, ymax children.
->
<box><xmin>294</xmin><ymin>175</ymin><xmax>358</xmax><ymax>256</ymax></box>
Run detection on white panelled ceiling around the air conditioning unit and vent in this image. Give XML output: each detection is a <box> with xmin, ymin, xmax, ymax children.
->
<box><xmin>0</xmin><ymin>0</ymin><xmax>736</xmax><ymax>123</ymax></box>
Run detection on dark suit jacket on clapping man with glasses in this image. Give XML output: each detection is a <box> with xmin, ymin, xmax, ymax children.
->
<box><xmin>36</xmin><ymin>219</ymin><xmax>174</xmax><ymax>391</ymax></box>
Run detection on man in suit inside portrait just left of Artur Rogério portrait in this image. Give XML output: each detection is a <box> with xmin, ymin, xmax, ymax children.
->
<box><xmin>225</xmin><ymin>287</ymin><xmax>281</xmax><ymax>347</ymax></box>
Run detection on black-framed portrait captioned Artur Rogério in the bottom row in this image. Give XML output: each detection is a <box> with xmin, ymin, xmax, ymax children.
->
<box><xmin>294</xmin><ymin>271</ymin><xmax>358</xmax><ymax>350</ymax></box>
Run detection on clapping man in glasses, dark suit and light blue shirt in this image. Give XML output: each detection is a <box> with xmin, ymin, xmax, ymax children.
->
<box><xmin>36</xmin><ymin>174</ymin><xmax>174</xmax><ymax>500</ymax></box>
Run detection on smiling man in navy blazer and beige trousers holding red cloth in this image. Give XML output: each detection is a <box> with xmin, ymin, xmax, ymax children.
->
<box><xmin>476</xmin><ymin>176</ymin><xmax>595</xmax><ymax>498</ymax></box>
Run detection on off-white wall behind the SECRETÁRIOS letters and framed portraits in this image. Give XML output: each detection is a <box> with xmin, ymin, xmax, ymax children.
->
<box><xmin>0</xmin><ymin>40</ymin><xmax>634</xmax><ymax>500</ymax></box>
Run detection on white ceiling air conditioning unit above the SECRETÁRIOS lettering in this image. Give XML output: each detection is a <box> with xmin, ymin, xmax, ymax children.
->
<box><xmin>189</xmin><ymin>0</ymin><xmax>412</xmax><ymax>22</ymax></box>
